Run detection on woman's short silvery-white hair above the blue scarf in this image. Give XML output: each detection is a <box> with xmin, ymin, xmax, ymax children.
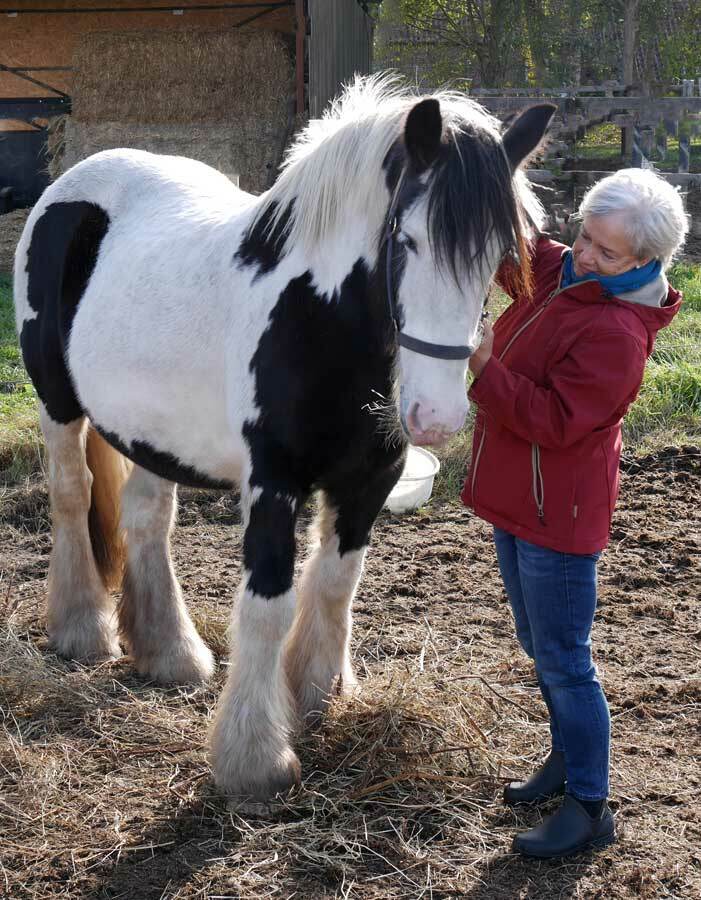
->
<box><xmin>579</xmin><ymin>169</ymin><xmax>689</xmax><ymax>269</ymax></box>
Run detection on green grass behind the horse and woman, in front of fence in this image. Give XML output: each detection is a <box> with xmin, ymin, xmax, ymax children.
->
<box><xmin>0</xmin><ymin>263</ymin><xmax>701</xmax><ymax>499</ymax></box>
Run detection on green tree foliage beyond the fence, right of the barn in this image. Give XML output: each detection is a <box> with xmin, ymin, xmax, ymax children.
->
<box><xmin>380</xmin><ymin>0</ymin><xmax>701</xmax><ymax>87</ymax></box>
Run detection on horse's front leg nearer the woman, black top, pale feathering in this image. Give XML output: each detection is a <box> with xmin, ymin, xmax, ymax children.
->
<box><xmin>285</xmin><ymin>457</ymin><xmax>403</xmax><ymax>724</ymax></box>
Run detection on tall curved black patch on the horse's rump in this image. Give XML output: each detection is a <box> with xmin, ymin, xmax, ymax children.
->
<box><xmin>20</xmin><ymin>202</ymin><xmax>110</xmax><ymax>424</ymax></box>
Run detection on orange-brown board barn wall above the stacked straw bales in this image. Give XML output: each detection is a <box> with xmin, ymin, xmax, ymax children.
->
<box><xmin>0</xmin><ymin>0</ymin><xmax>295</xmax><ymax>97</ymax></box>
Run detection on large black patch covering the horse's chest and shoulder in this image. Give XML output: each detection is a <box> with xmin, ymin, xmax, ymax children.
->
<box><xmin>243</xmin><ymin>259</ymin><xmax>406</xmax><ymax>553</ymax></box>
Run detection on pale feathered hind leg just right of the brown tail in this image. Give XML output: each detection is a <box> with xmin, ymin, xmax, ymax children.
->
<box><xmin>119</xmin><ymin>466</ymin><xmax>214</xmax><ymax>683</ymax></box>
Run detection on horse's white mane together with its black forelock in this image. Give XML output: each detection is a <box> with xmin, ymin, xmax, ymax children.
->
<box><xmin>251</xmin><ymin>75</ymin><xmax>543</xmax><ymax>286</ymax></box>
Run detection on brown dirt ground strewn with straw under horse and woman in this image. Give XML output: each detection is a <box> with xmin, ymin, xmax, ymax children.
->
<box><xmin>0</xmin><ymin>447</ymin><xmax>701</xmax><ymax>900</ymax></box>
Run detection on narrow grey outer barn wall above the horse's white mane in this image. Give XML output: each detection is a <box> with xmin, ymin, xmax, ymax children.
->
<box><xmin>309</xmin><ymin>0</ymin><xmax>373</xmax><ymax>118</ymax></box>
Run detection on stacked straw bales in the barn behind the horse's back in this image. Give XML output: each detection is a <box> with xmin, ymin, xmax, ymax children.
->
<box><xmin>62</xmin><ymin>29</ymin><xmax>294</xmax><ymax>192</ymax></box>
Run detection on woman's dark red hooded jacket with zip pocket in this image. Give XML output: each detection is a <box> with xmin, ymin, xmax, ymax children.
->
<box><xmin>462</xmin><ymin>238</ymin><xmax>681</xmax><ymax>553</ymax></box>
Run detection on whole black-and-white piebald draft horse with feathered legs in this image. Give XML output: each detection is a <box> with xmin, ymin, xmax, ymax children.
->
<box><xmin>14</xmin><ymin>78</ymin><xmax>554</xmax><ymax>798</ymax></box>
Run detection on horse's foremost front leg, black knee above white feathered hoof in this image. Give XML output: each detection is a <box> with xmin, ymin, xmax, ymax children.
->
<box><xmin>210</xmin><ymin>488</ymin><xmax>300</xmax><ymax>799</ymax></box>
